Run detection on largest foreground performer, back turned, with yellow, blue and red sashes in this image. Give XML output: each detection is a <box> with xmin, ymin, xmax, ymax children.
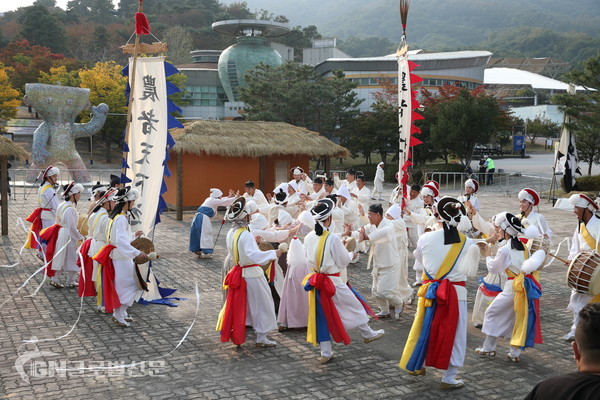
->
<box><xmin>400</xmin><ymin>197</ymin><xmax>479</xmax><ymax>390</ymax></box>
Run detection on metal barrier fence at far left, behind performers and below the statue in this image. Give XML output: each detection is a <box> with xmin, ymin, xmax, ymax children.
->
<box><xmin>8</xmin><ymin>168</ymin><xmax>121</xmax><ymax>199</ymax></box>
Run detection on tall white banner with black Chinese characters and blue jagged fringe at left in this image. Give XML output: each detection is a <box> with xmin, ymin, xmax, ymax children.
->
<box><xmin>127</xmin><ymin>57</ymin><xmax>168</xmax><ymax>235</ymax></box>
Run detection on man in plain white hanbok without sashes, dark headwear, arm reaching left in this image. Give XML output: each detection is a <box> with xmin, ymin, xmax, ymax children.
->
<box><xmin>347</xmin><ymin>204</ymin><xmax>404</xmax><ymax>319</ymax></box>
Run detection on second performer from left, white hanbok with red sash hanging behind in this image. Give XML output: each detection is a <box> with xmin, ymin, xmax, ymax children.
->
<box><xmin>41</xmin><ymin>182</ymin><xmax>84</xmax><ymax>289</ymax></box>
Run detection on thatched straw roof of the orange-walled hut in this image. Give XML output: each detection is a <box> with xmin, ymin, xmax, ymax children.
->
<box><xmin>171</xmin><ymin>121</ymin><xmax>350</xmax><ymax>158</ymax></box>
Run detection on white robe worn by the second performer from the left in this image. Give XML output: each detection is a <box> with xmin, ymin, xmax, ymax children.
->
<box><xmin>48</xmin><ymin>201</ymin><xmax>83</xmax><ymax>272</ymax></box>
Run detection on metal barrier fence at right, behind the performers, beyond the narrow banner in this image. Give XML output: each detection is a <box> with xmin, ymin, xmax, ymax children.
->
<box><xmin>426</xmin><ymin>171</ymin><xmax>552</xmax><ymax>195</ymax></box>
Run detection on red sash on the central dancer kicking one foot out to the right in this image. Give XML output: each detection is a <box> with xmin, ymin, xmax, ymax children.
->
<box><xmin>308</xmin><ymin>272</ymin><xmax>350</xmax><ymax>344</ymax></box>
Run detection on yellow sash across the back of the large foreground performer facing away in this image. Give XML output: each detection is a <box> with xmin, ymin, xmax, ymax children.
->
<box><xmin>399</xmin><ymin>232</ymin><xmax>467</xmax><ymax>370</ymax></box>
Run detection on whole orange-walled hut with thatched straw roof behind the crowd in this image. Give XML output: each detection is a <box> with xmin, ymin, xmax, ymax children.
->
<box><xmin>164</xmin><ymin>121</ymin><xmax>350</xmax><ymax>217</ymax></box>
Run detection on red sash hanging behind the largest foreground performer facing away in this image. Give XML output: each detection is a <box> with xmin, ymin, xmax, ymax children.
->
<box><xmin>424</xmin><ymin>279</ymin><xmax>465</xmax><ymax>369</ymax></box>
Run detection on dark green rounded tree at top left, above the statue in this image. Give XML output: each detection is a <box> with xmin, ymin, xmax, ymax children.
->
<box><xmin>19</xmin><ymin>6</ymin><xmax>65</xmax><ymax>53</ymax></box>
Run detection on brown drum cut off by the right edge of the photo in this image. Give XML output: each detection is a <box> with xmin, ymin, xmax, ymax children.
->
<box><xmin>567</xmin><ymin>251</ymin><xmax>600</xmax><ymax>296</ymax></box>
